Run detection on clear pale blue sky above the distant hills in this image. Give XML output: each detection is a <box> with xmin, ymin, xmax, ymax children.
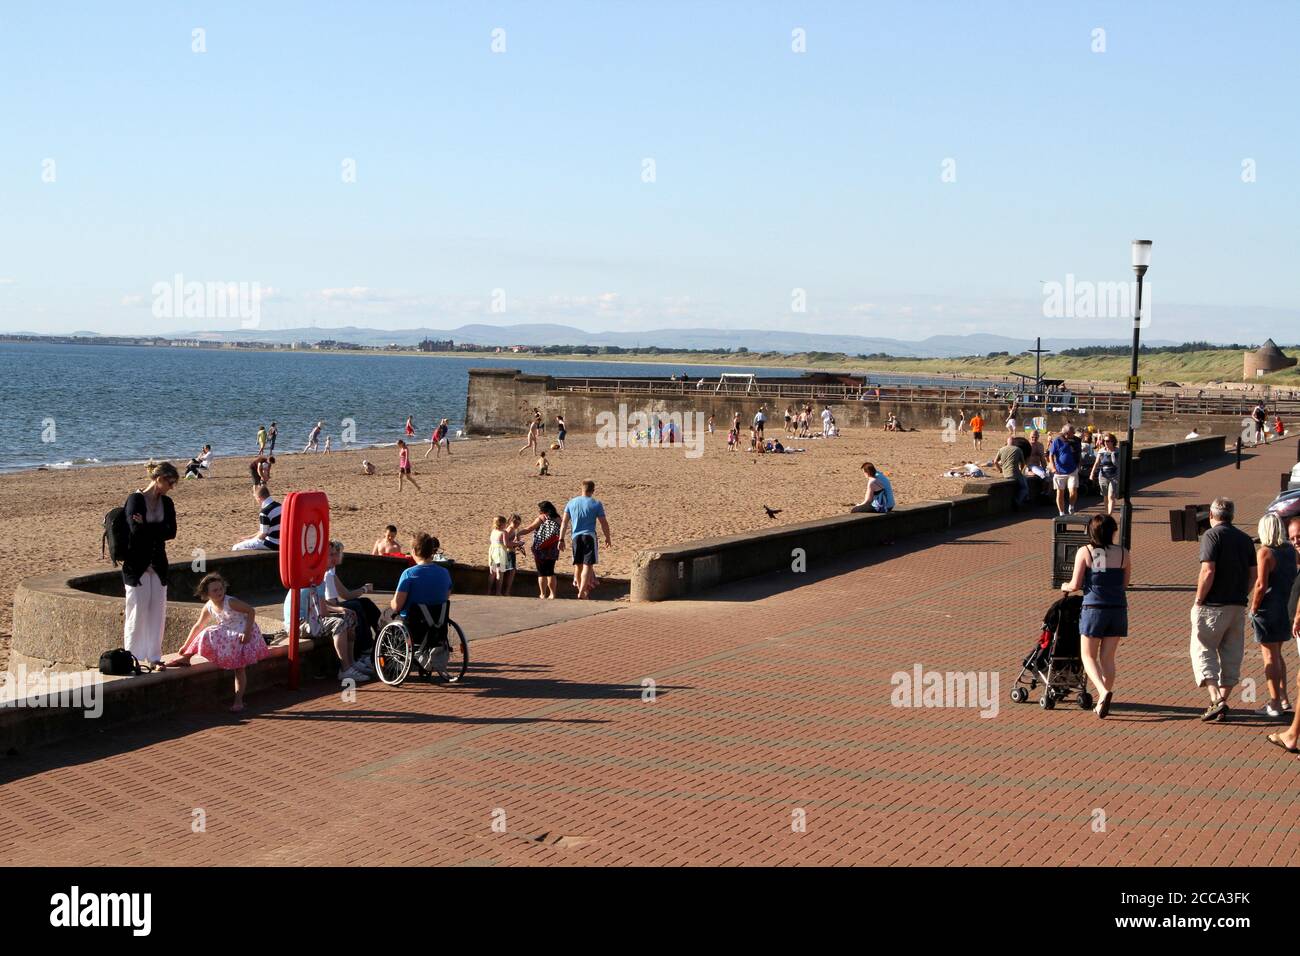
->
<box><xmin>0</xmin><ymin>0</ymin><xmax>1300</xmax><ymax>341</ymax></box>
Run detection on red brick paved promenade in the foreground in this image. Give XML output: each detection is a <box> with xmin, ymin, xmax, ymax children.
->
<box><xmin>0</xmin><ymin>440</ymin><xmax>1300</xmax><ymax>865</ymax></box>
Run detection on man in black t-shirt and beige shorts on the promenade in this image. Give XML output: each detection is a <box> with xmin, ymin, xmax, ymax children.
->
<box><xmin>1191</xmin><ymin>498</ymin><xmax>1256</xmax><ymax>721</ymax></box>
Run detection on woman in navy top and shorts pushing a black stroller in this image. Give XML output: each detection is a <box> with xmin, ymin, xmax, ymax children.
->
<box><xmin>1061</xmin><ymin>515</ymin><xmax>1132</xmax><ymax>717</ymax></box>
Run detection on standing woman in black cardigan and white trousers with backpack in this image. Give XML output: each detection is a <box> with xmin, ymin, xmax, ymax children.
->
<box><xmin>122</xmin><ymin>462</ymin><xmax>181</xmax><ymax>670</ymax></box>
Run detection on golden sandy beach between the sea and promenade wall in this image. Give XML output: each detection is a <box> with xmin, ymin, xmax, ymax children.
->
<box><xmin>0</xmin><ymin>425</ymin><xmax>1206</xmax><ymax>667</ymax></box>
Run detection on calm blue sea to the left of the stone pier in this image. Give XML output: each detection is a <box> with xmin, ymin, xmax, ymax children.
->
<box><xmin>0</xmin><ymin>342</ymin><xmax>800</xmax><ymax>471</ymax></box>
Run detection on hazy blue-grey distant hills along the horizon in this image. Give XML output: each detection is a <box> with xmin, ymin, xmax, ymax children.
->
<box><xmin>177</xmin><ymin>324</ymin><xmax>1177</xmax><ymax>358</ymax></box>
